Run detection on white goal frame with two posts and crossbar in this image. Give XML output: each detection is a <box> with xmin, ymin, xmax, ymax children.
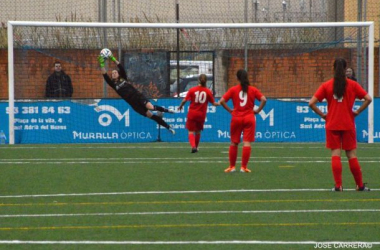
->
<box><xmin>7</xmin><ymin>21</ymin><xmax>375</xmax><ymax>144</ymax></box>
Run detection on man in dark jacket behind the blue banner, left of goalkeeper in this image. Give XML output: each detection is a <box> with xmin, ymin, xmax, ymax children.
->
<box><xmin>45</xmin><ymin>62</ymin><xmax>73</xmax><ymax>98</ymax></box>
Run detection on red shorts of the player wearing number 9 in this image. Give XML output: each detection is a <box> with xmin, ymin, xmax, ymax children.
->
<box><xmin>230</xmin><ymin>115</ymin><xmax>256</xmax><ymax>144</ymax></box>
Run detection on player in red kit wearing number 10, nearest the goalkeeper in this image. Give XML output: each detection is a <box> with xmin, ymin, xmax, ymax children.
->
<box><xmin>178</xmin><ymin>74</ymin><xmax>219</xmax><ymax>153</ymax></box>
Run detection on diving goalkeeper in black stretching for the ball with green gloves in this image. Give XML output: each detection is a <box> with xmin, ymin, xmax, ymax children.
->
<box><xmin>98</xmin><ymin>55</ymin><xmax>175</xmax><ymax>135</ymax></box>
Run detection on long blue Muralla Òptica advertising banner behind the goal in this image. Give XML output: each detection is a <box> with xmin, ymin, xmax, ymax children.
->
<box><xmin>0</xmin><ymin>98</ymin><xmax>380</xmax><ymax>144</ymax></box>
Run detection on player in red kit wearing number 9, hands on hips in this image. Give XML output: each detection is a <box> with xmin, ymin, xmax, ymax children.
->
<box><xmin>219</xmin><ymin>69</ymin><xmax>267</xmax><ymax>173</ymax></box>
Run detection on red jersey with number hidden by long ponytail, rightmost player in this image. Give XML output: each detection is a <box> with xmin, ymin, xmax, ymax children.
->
<box><xmin>314</xmin><ymin>78</ymin><xmax>367</xmax><ymax>130</ymax></box>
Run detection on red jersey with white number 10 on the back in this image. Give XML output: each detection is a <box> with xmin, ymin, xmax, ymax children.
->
<box><xmin>185</xmin><ymin>86</ymin><xmax>215</xmax><ymax>117</ymax></box>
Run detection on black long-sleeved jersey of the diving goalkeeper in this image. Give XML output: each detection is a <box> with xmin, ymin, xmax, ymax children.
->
<box><xmin>103</xmin><ymin>63</ymin><xmax>146</xmax><ymax>104</ymax></box>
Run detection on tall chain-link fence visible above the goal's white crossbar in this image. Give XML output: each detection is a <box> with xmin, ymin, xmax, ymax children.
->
<box><xmin>0</xmin><ymin>0</ymin><xmax>380</xmax><ymax>45</ymax></box>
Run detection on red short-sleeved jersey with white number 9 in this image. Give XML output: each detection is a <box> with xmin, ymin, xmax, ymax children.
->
<box><xmin>223</xmin><ymin>84</ymin><xmax>263</xmax><ymax>117</ymax></box>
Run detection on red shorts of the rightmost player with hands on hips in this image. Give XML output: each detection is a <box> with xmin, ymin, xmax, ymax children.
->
<box><xmin>326</xmin><ymin>129</ymin><xmax>356</xmax><ymax>150</ymax></box>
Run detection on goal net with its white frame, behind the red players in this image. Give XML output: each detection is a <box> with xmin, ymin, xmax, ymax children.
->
<box><xmin>6</xmin><ymin>22</ymin><xmax>374</xmax><ymax>144</ymax></box>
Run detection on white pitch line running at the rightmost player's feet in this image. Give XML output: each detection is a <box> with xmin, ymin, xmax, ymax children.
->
<box><xmin>0</xmin><ymin>188</ymin><xmax>380</xmax><ymax>199</ymax></box>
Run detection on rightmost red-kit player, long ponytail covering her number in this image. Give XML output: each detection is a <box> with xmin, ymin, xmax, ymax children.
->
<box><xmin>309</xmin><ymin>58</ymin><xmax>372</xmax><ymax>191</ymax></box>
